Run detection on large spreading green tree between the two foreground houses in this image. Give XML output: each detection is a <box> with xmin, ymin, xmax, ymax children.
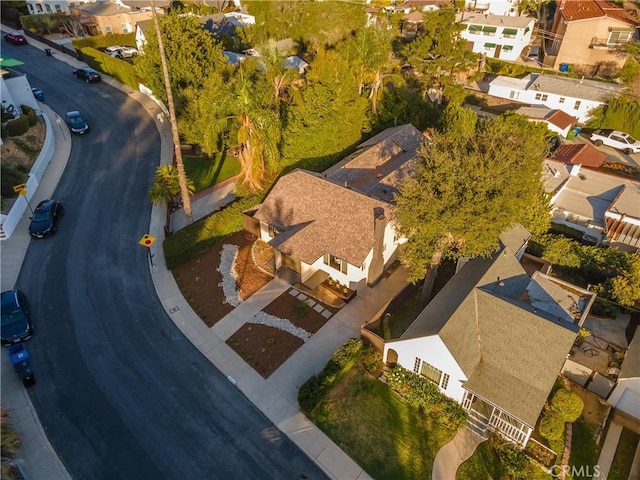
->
<box><xmin>396</xmin><ymin>114</ymin><xmax>549</xmax><ymax>300</ymax></box>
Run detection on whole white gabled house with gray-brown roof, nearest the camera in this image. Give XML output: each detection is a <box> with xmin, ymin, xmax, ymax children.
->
<box><xmin>383</xmin><ymin>225</ymin><xmax>595</xmax><ymax>446</ymax></box>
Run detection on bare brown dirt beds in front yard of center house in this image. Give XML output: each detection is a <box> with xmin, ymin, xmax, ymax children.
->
<box><xmin>173</xmin><ymin>233</ymin><xmax>337</xmax><ymax>378</ymax></box>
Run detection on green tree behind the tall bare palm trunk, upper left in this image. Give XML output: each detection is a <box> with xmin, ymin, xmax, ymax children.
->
<box><xmin>135</xmin><ymin>13</ymin><xmax>227</xmax><ymax>109</ymax></box>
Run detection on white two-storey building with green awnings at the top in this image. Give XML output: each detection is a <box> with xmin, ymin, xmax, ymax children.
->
<box><xmin>457</xmin><ymin>13</ymin><xmax>535</xmax><ymax>61</ymax></box>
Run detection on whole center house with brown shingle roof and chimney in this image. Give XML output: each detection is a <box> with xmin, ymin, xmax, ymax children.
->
<box><xmin>244</xmin><ymin>125</ymin><xmax>424</xmax><ymax>290</ymax></box>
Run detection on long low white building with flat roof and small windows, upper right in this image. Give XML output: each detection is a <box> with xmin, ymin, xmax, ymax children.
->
<box><xmin>488</xmin><ymin>73</ymin><xmax>624</xmax><ymax>122</ymax></box>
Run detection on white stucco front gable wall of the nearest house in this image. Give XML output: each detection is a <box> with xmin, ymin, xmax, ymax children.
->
<box><xmin>383</xmin><ymin>335</ymin><xmax>467</xmax><ymax>402</ymax></box>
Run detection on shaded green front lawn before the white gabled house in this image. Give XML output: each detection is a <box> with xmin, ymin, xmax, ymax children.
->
<box><xmin>310</xmin><ymin>366</ymin><xmax>456</xmax><ymax>480</ymax></box>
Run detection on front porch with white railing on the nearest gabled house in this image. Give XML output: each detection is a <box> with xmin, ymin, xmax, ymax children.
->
<box><xmin>462</xmin><ymin>391</ymin><xmax>533</xmax><ymax>447</ymax></box>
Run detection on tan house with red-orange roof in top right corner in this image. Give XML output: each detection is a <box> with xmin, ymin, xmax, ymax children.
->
<box><xmin>543</xmin><ymin>0</ymin><xmax>639</xmax><ymax>74</ymax></box>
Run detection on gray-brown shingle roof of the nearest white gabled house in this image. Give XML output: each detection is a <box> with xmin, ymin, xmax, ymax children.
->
<box><xmin>400</xmin><ymin>226</ymin><xmax>593</xmax><ymax>426</ymax></box>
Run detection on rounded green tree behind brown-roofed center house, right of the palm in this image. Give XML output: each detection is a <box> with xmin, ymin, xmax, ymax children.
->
<box><xmin>282</xmin><ymin>50</ymin><xmax>368</xmax><ymax>164</ymax></box>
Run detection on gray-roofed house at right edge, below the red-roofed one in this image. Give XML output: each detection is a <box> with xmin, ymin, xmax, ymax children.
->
<box><xmin>542</xmin><ymin>159</ymin><xmax>640</xmax><ymax>251</ymax></box>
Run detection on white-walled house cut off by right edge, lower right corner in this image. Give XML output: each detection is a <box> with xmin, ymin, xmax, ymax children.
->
<box><xmin>607</xmin><ymin>329</ymin><xmax>640</xmax><ymax>425</ymax></box>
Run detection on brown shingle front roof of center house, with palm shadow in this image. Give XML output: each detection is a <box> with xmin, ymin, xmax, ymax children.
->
<box><xmin>254</xmin><ymin>170</ymin><xmax>391</xmax><ymax>266</ymax></box>
